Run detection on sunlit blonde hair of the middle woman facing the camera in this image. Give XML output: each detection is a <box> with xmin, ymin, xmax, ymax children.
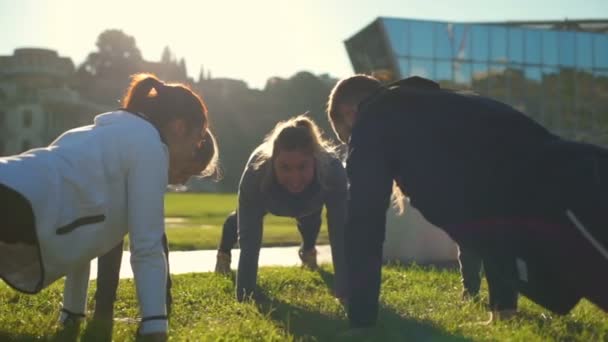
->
<box><xmin>251</xmin><ymin>113</ymin><xmax>337</xmax><ymax>190</ymax></box>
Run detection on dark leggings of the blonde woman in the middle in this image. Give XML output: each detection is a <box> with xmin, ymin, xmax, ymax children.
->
<box><xmin>218</xmin><ymin>211</ymin><xmax>321</xmax><ymax>253</ymax></box>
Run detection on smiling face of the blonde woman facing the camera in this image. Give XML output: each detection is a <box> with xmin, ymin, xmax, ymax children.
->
<box><xmin>274</xmin><ymin>150</ymin><xmax>315</xmax><ymax>194</ymax></box>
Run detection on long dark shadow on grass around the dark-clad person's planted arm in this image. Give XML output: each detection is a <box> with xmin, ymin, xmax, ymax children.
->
<box><xmin>256</xmin><ymin>269</ymin><xmax>469</xmax><ymax>341</ymax></box>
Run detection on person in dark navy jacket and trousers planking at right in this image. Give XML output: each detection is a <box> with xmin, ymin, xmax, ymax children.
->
<box><xmin>328</xmin><ymin>75</ymin><xmax>608</xmax><ymax>327</ymax></box>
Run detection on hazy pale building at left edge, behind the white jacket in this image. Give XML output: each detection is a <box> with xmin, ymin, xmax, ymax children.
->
<box><xmin>0</xmin><ymin>48</ymin><xmax>104</xmax><ymax>155</ymax></box>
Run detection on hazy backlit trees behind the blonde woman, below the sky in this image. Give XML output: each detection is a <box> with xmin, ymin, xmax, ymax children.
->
<box><xmin>75</xmin><ymin>29</ymin><xmax>337</xmax><ymax>192</ymax></box>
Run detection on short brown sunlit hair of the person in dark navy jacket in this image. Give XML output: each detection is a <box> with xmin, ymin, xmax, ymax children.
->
<box><xmin>327</xmin><ymin>74</ymin><xmax>382</xmax><ymax>143</ymax></box>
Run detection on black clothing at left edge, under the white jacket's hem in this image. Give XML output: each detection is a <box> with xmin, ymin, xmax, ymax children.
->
<box><xmin>0</xmin><ymin>184</ymin><xmax>38</xmax><ymax>245</ymax></box>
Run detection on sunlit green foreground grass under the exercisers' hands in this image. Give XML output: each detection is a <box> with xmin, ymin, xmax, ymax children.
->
<box><xmin>0</xmin><ymin>266</ymin><xmax>608</xmax><ymax>341</ymax></box>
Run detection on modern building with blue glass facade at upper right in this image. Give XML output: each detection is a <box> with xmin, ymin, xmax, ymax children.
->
<box><xmin>345</xmin><ymin>18</ymin><xmax>608</xmax><ymax>145</ymax></box>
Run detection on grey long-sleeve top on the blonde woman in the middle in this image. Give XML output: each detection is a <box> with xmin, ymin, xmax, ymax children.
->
<box><xmin>236</xmin><ymin>151</ymin><xmax>347</xmax><ymax>300</ymax></box>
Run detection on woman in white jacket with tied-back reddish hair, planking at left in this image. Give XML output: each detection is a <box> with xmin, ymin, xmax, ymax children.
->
<box><xmin>0</xmin><ymin>74</ymin><xmax>218</xmax><ymax>339</ymax></box>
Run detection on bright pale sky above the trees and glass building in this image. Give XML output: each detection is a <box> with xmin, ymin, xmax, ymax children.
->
<box><xmin>0</xmin><ymin>0</ymin><xmax>608</xmax><ymax>88</ymax></box>
